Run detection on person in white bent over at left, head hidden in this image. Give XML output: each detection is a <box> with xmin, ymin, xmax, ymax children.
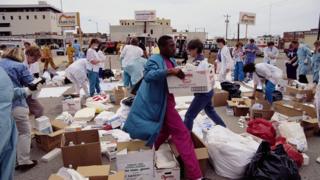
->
<box><xmin>65</xmin><ymin>58</ymin><xmax>89</xmax><ymax>96</ymax></box>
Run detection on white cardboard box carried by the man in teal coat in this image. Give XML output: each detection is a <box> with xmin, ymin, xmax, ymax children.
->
<box><xmin>167</xmin><ymin>65</ymin><xmax>214</xmax><ymax>96</ymax></box>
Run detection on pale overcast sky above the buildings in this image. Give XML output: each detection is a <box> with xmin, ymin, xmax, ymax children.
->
<box><xmin>0</xmin><ymin>0</ymin><xmax>320</xmax><ymax>38</ymax></box>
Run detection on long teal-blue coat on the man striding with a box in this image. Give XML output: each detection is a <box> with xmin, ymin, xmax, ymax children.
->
<box><xmin>123</xmin><ymin>54</ymin><xmax>177</xmax><ymax>146</ymax></box>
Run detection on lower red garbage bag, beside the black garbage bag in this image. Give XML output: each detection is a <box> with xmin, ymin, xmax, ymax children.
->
<box><xmin>275</xmin><ymin>136</ymin><xmax>303</xmax><ymax>167</ymax></box>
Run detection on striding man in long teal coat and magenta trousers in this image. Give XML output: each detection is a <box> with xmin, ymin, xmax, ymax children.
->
<box><xmin>123</xmin><ymin>36</ymin><xmax>202</xmax><ymax>180</ymax></box>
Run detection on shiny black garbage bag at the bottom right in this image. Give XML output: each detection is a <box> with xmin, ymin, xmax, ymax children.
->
<box><xmin>242</xmin><ymin>141</ymin><xmax>301</xmax><ymax>180</ymax></box>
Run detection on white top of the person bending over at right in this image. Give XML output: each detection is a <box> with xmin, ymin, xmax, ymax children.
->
<box><xmin>253</xmin><ymin>63</ymin><xmax>283</xmax><ymax>85</ymax></box>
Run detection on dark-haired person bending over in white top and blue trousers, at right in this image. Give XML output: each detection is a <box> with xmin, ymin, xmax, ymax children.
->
<box><xmin>243</xmin><ymin>63</ymin><xmax>282</xmax><ymax>103</ymax></box>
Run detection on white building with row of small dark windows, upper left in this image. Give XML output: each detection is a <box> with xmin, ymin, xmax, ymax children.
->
<box><xmin>0</xmin><ymin>1</ymin><xmax>61</xmax><ymax>36</ymax></box>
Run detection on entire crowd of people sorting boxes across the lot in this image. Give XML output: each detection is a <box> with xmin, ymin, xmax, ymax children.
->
<box><xmin>0</xmin><ymin>36</ymin><xmax>320</xmax><ymax>179</ymax></box>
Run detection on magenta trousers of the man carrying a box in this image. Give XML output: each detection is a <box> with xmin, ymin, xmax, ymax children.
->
<box><xmin>155</xmin><ymin>94</ymin><xmax>202</xmax><ymax>180</ymax></box>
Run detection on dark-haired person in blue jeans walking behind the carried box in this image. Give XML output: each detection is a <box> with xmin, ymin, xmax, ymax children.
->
<box><xmin>184</xmin><ymin>39</ymin><xmax>226</xmax><ymax>131</ymax></box>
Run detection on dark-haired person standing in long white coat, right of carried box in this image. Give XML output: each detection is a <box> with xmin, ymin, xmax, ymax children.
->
<box><xmin>216</xmin><ymin>38</ymin><xmax>234</xmax><ymax>83</ymax></box>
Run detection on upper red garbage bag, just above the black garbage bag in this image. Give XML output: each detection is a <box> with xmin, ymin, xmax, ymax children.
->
<box><xmin>247</xmin><ymin>118</ymin><xmax>276</xmax><ymax>145</ymax></box>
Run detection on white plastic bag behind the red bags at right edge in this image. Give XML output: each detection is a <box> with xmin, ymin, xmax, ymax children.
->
<box><xmin>278</xmin><ymin>122</ymin><xmax>308</xmax><ymax>152</ymax></box>
